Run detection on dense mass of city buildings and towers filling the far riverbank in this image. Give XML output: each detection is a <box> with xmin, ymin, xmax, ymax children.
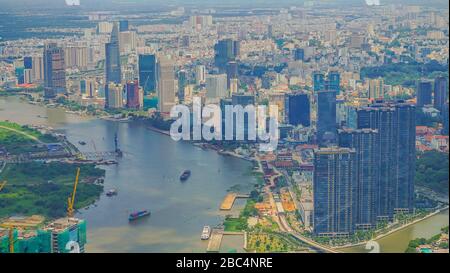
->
<box><xmin>0</xmin><ymin>2</ymin><xmax>449</xmax><ymax>236</ymax></box>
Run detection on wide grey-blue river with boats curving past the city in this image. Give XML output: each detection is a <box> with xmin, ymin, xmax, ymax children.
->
<box><xmin>0</xmin><ymin>97</ymin><xmax>449</xmax><ymax>252</ymax></box>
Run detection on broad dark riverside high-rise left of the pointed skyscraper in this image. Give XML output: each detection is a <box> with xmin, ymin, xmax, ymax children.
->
<box><xmin>43</xmin><ymin>43</ymin><xmax>66</xmax><ymax>98</ymax></box>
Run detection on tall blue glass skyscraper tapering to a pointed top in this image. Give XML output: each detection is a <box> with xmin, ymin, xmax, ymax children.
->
<box><xmin>105</xmin><ymin>23</ymin><xmax>122</xmax><ymax>83</ymax></box>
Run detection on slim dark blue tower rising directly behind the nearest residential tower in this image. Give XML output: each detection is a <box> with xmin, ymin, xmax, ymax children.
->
<box><xmin>317</xmin><ymin>91</ymin><xmax>337</xmax><ymax>146</ymax></box>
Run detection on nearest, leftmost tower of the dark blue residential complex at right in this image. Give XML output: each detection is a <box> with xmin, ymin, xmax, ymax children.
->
<box><xmin>313</xmin><ymin>147</ymin><xmax>357</xmax><ymax>236</ymax></box>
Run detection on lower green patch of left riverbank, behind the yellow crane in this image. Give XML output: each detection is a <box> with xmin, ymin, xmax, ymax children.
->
<box><xmin>0</xmin><ymin>162</ymin><xmax>105</xmax><ymax>219</ymax></box>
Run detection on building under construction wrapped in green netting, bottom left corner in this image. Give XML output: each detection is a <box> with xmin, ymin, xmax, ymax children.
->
<box><xmin>0</xmin><ymin>216</ymin><xmax>86</xmax><ymax>253</ymax></box>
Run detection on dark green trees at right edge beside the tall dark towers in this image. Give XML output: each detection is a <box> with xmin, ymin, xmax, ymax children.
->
<box><xmin>415</xmin><ymin>151</ymin><xmax>449</xmax><ymax>194</ymax></box>
